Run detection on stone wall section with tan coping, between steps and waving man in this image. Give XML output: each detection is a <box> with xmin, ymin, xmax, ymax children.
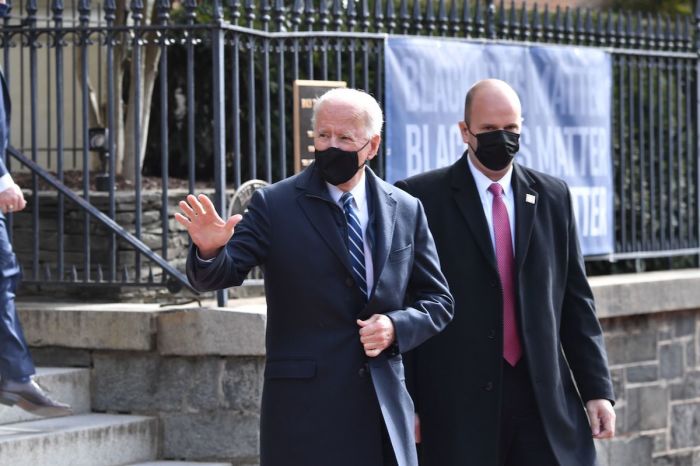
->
<box><xmin>20</xmin><ymin>299</ymin><xmax>266</xmax><ymax>466</ymax></box>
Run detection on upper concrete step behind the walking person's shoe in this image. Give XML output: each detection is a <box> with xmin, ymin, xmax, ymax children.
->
<box><xmin>0</xmin><ymin>367</ymin><xmax>90</xmax><ymax>425</ymax></box>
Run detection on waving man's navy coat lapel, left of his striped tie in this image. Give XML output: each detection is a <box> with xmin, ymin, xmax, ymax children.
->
<box><xmin>296</xmin><ymin>165</ymin><xmax>352</xmax><ymax>274</ymax></box>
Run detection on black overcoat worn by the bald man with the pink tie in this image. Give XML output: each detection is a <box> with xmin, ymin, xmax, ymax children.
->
<box><xmin>397</xmin><ymin>153</ymin><xmax>613</xmax><ymax>466</ymax></box>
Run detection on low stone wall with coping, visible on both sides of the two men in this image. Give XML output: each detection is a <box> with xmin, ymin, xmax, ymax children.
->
<box><xmin>20</xmin><ymin>270</ymin><xmax>700</xmax><ymax>466</ymax></box>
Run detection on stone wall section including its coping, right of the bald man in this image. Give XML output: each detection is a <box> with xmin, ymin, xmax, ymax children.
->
<box><xmin>591</xmin><ymin>271</ymin><xmax>700</xmax><ymax>466</ymax></box>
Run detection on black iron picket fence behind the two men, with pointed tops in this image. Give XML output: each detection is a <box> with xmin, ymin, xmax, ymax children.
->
<box><xmin>0</xmin><ymin>0</ymin><xmax>700</xmax><ymax>298</ymax></box>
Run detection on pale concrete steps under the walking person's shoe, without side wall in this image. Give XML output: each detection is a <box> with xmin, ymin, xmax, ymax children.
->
<box><xmin>0</xmin><ymin>368</ymin><xmax>230</xmax><ymax>466</ymax></box>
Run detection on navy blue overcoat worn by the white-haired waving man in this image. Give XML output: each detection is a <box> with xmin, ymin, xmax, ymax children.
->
<box><xmin>187</xmin><ymin>165</ymin><xmax>453</xmax><ymax>466</ymax></box>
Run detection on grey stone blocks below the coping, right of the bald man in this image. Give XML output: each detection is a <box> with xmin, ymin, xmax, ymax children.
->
<box><xmin>599</xmin><ymin>311</ymin><xmax>700</xmax><ymax>466</ymax></box>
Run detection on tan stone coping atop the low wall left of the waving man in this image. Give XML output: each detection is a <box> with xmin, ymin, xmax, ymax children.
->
<box><xmin>17</xmin><ymin>298</ymin><xmax>266</xmax><ymax>354</ymax></box>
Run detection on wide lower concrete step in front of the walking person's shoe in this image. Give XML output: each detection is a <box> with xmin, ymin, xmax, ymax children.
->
<box><xmin>0</xmin><ymin>414</ymin><xmax>158</xmax><ymax>466</ymax></box>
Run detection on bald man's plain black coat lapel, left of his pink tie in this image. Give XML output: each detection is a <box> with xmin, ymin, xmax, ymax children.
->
<box><xmin>451</xmin><ymin>152</ymin><xmax>498</xmax><ymax>271</ymax></box>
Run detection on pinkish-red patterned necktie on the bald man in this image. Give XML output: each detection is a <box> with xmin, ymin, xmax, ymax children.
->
<box><xmin>489</xmin><ymin>183</ymin><xmax>523</xmax><ymax>367</ymax></box>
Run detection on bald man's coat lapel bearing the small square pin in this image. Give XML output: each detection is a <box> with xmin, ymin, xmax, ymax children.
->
<box><xmin>512</xmin><ymin>164</ymin><xmax>538</xmax><ymax>272</ymax></box>
